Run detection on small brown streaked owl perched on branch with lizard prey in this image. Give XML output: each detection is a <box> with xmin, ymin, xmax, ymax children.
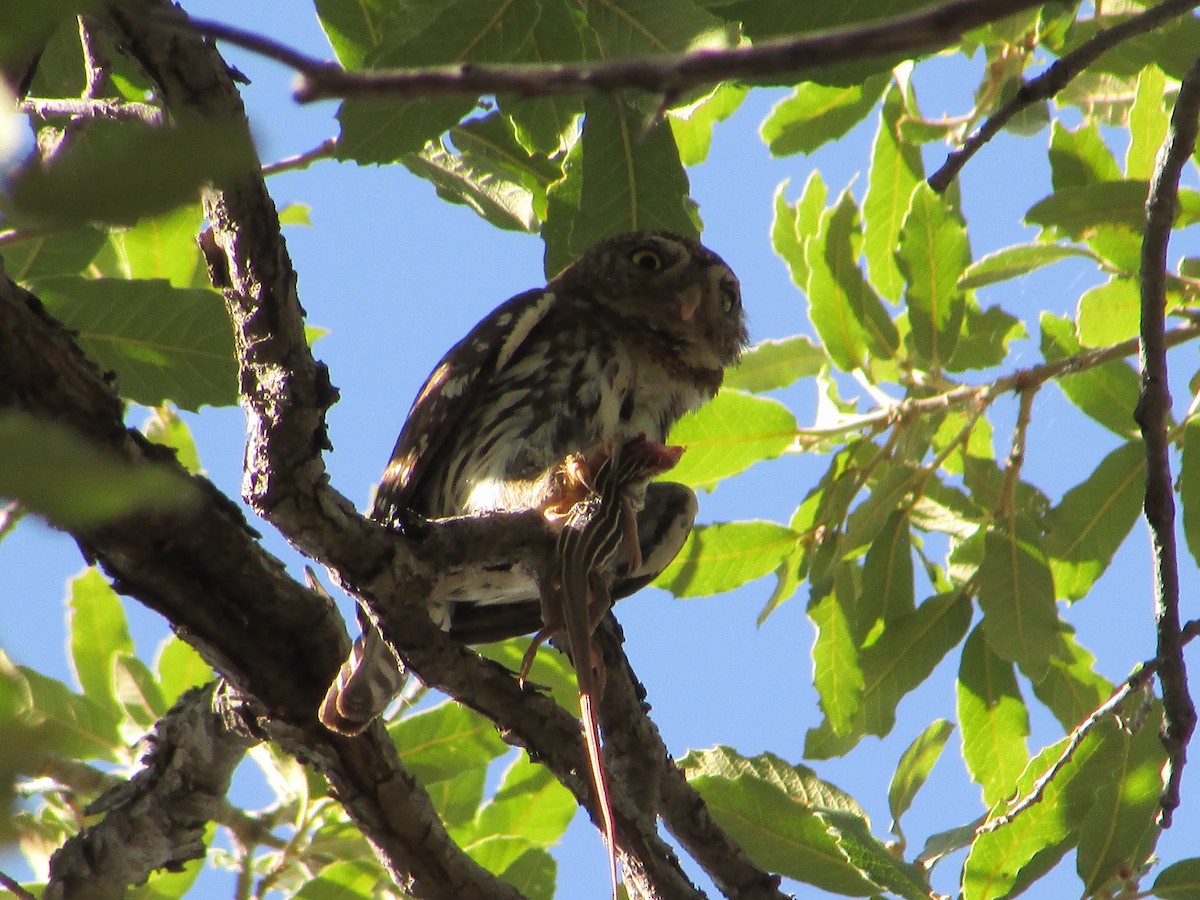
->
<box><xmin>319</xmin><ymin>232</ymin><xmax>746</xmax><ymax>734</ymax></box>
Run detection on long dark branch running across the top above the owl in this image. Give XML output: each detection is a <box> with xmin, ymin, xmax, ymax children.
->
<box><xmin>172</xmin><ymin>0</ymin><xmax>1040</xmax><ymax>103</ymax></box>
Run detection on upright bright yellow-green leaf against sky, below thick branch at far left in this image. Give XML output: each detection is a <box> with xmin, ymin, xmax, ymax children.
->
<box><xmin>67</xmin><ymin>569</ymin><xmax>133</xmax><ymax>712</ymax></box>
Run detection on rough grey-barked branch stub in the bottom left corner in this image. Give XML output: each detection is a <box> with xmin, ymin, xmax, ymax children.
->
<box><xmin>43</xmin><ymin>684</ymin><xmax>253</xmax><ymax>900</ymax></box>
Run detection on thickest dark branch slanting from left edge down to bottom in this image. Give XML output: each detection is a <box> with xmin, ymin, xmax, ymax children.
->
<box><xmin>0</xmin><ymin>270</ymin><xmax>514</xmax><ymax>900</ymax></box>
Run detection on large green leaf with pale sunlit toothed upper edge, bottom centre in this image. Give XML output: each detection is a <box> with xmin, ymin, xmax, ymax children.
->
<box><xmin>679</xmin><ymin>748</ymin><xmax>878</xmax><ymax>896</ymax></box>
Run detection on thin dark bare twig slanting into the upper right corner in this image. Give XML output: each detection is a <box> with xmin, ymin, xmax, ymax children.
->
<box><xmin>929</xmin><ymin>0</ymin><xmax>1200</xmax><ymax>193</ymax></box>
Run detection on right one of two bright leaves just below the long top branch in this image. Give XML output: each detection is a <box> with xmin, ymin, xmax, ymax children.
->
<box><xmin>760</xmin><ymin>74</ymin><xmax>890</xmax><ymax>156</ymax></box>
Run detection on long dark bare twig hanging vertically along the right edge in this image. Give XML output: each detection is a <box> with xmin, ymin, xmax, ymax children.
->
<box><xmin>1134</xmin><ymin>47</ymin><xmax>1200</xmax><ymax>828</ymax></box>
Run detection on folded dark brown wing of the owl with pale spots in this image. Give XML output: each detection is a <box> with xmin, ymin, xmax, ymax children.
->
<box><xmin>371</xmin><ymin>288</ymin><xmax>554</xmax><ymax>522</ymax></box>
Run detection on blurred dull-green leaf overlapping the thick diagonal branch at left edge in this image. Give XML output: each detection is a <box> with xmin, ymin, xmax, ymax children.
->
<box><xmin>0</xmin><ymin>412</ymin><xmax>197</xmax><ymax>528</ymax></box>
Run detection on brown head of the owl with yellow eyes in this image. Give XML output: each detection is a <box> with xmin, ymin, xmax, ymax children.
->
<box><xmin>548</xmin><ymin>232</ymin><xmax>748</xmax><ymax>370</ymax></box>
